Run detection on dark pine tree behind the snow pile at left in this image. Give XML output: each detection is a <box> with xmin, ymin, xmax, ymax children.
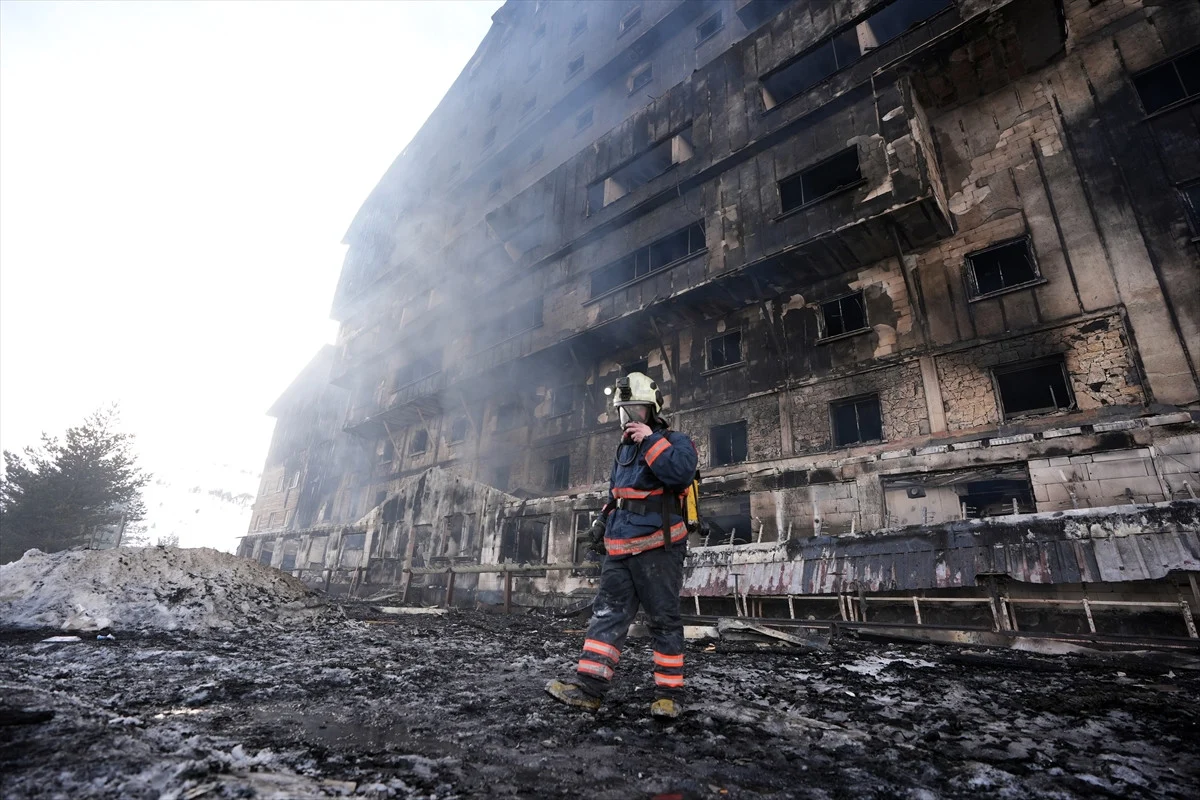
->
<box><xmin>0</xmin><ymin>405</ymin><xmax>150</xmax><ymax>563</ymax></box>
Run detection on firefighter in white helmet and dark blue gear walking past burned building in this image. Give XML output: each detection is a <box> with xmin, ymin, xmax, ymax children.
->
<box><xmin>546</xmin><ymin>372</ymin><xmax>696</xmax><ymax>718</ymax></box>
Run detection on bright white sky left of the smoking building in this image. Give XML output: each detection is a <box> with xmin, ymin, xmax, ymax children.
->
<box><xmin>0</xmin><ymin>0</ymin><xmax>502</xmax><ymax>520</ymax></box>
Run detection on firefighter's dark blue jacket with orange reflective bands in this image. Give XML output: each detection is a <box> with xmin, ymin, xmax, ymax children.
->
<box><xmin>604</xmin><ymin>428</ymin><xmax>696</xmax><ymax>558</ymax></box>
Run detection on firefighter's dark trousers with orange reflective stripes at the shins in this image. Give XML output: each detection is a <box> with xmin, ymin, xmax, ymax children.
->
<box><xmin>576</xmin><ymin>542</ymin><xmax>688</xmax><ymax>698</ymax></box>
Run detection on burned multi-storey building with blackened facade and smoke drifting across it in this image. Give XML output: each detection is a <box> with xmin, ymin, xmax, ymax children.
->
<box><xmin>242</xmin><ymin>0</ymin><xmax>1200</xmax><ymax>621</ymax></box>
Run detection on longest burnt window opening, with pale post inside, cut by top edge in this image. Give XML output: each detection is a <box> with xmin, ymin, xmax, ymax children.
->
<box><xmin>762</xmin><ymin>0</ymin><xmax>952</xmax><ymax>110</ymax></box>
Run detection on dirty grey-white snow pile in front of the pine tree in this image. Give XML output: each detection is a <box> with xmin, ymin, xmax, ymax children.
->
<box><xmin>0</xmin><ymin>547</ymin><xmax>324</xmax><ymax>631</ymax></box>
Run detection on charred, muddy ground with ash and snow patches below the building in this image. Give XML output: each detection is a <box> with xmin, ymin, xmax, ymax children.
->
<box><xmin>0</xmin><ymin>610</ymin><xmax>1200</xmax><ymax>800</ymax></box>
